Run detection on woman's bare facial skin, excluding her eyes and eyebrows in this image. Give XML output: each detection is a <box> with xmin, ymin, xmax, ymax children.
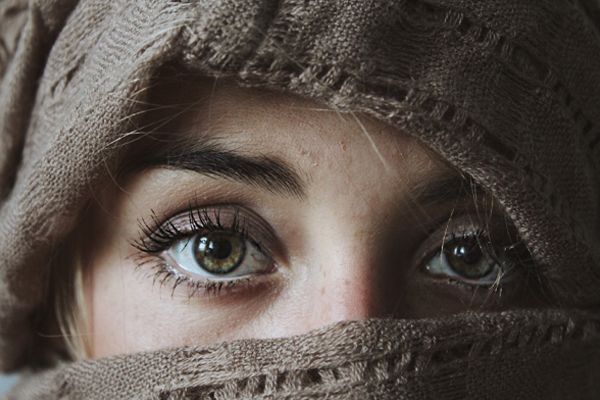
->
<box><xmin>84</xmin><ymin>76</ymin><xmax>540</xmax><ymax>358</ymax></box>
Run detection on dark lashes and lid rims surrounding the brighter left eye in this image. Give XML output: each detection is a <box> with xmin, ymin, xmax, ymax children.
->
<box><xmin>131</xmin><ymin>206</ymin><xmax>271</xmax><ymax>298</ymax></box>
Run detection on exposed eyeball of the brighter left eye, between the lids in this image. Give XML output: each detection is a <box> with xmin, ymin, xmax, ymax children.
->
<box><xmin>163</xmin><ymin>231</ymin><xmax>275</xmax><ymax>280</ymax></box>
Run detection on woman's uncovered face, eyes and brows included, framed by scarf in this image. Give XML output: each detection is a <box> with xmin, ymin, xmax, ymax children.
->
<box><xmin>84</xmin><ymin>76</ymin><xmax>535</xmax><ymax>357</ymax></box>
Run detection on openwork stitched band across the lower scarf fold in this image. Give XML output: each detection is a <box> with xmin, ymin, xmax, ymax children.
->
<box><xmin>159</xmin><ymin>320</ymin><xmax>600</xmax><ymax>399</ymax></box>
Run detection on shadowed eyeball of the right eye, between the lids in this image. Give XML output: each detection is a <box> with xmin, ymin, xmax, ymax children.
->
<box><xmin>425</xmin><ymin>234</ymin><xmax>505</xmax><ymax>285</ymax></box>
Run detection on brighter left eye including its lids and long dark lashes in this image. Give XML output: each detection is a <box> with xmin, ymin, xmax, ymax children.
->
<box><xmin>133</xmin><ymin>205</ymin><xmax>279</xmax><ymax>295</ymax></box>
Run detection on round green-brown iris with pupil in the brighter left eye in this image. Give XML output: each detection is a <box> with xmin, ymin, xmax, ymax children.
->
<box><xmin>193</xmin><ymin>232</ymin><xmax>246</xmax><ymax>275</ymax></box>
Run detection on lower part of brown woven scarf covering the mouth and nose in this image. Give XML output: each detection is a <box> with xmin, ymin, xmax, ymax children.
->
<box><xmin>5</xmin><ymin>311</ymin><xmax>600</xmax><ymax>400</ymax></box>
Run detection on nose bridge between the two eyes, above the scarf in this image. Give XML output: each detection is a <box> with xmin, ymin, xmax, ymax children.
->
<box><xmin>296</xmin><ymin>158</ymin><xmax>404</xmax><ymax>328</ymax></box>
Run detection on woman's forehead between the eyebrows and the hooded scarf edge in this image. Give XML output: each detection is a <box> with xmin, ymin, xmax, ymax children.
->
<box><xmin>137</xmin><ymin>76</ymin><xmax>451</xmax><ymax>182</ymax></box>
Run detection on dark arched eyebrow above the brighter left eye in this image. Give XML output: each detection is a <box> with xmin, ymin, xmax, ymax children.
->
<box><xmin>135</xmin><ymin>144</ymin><xmax>306</xmax><ymax>198</ymax></box>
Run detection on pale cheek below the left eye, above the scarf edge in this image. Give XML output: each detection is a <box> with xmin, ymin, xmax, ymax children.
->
<box><xmin>85</xmin><ymin>238</ymin><xmax>302</xmax><ymax>358</ymax></box>
